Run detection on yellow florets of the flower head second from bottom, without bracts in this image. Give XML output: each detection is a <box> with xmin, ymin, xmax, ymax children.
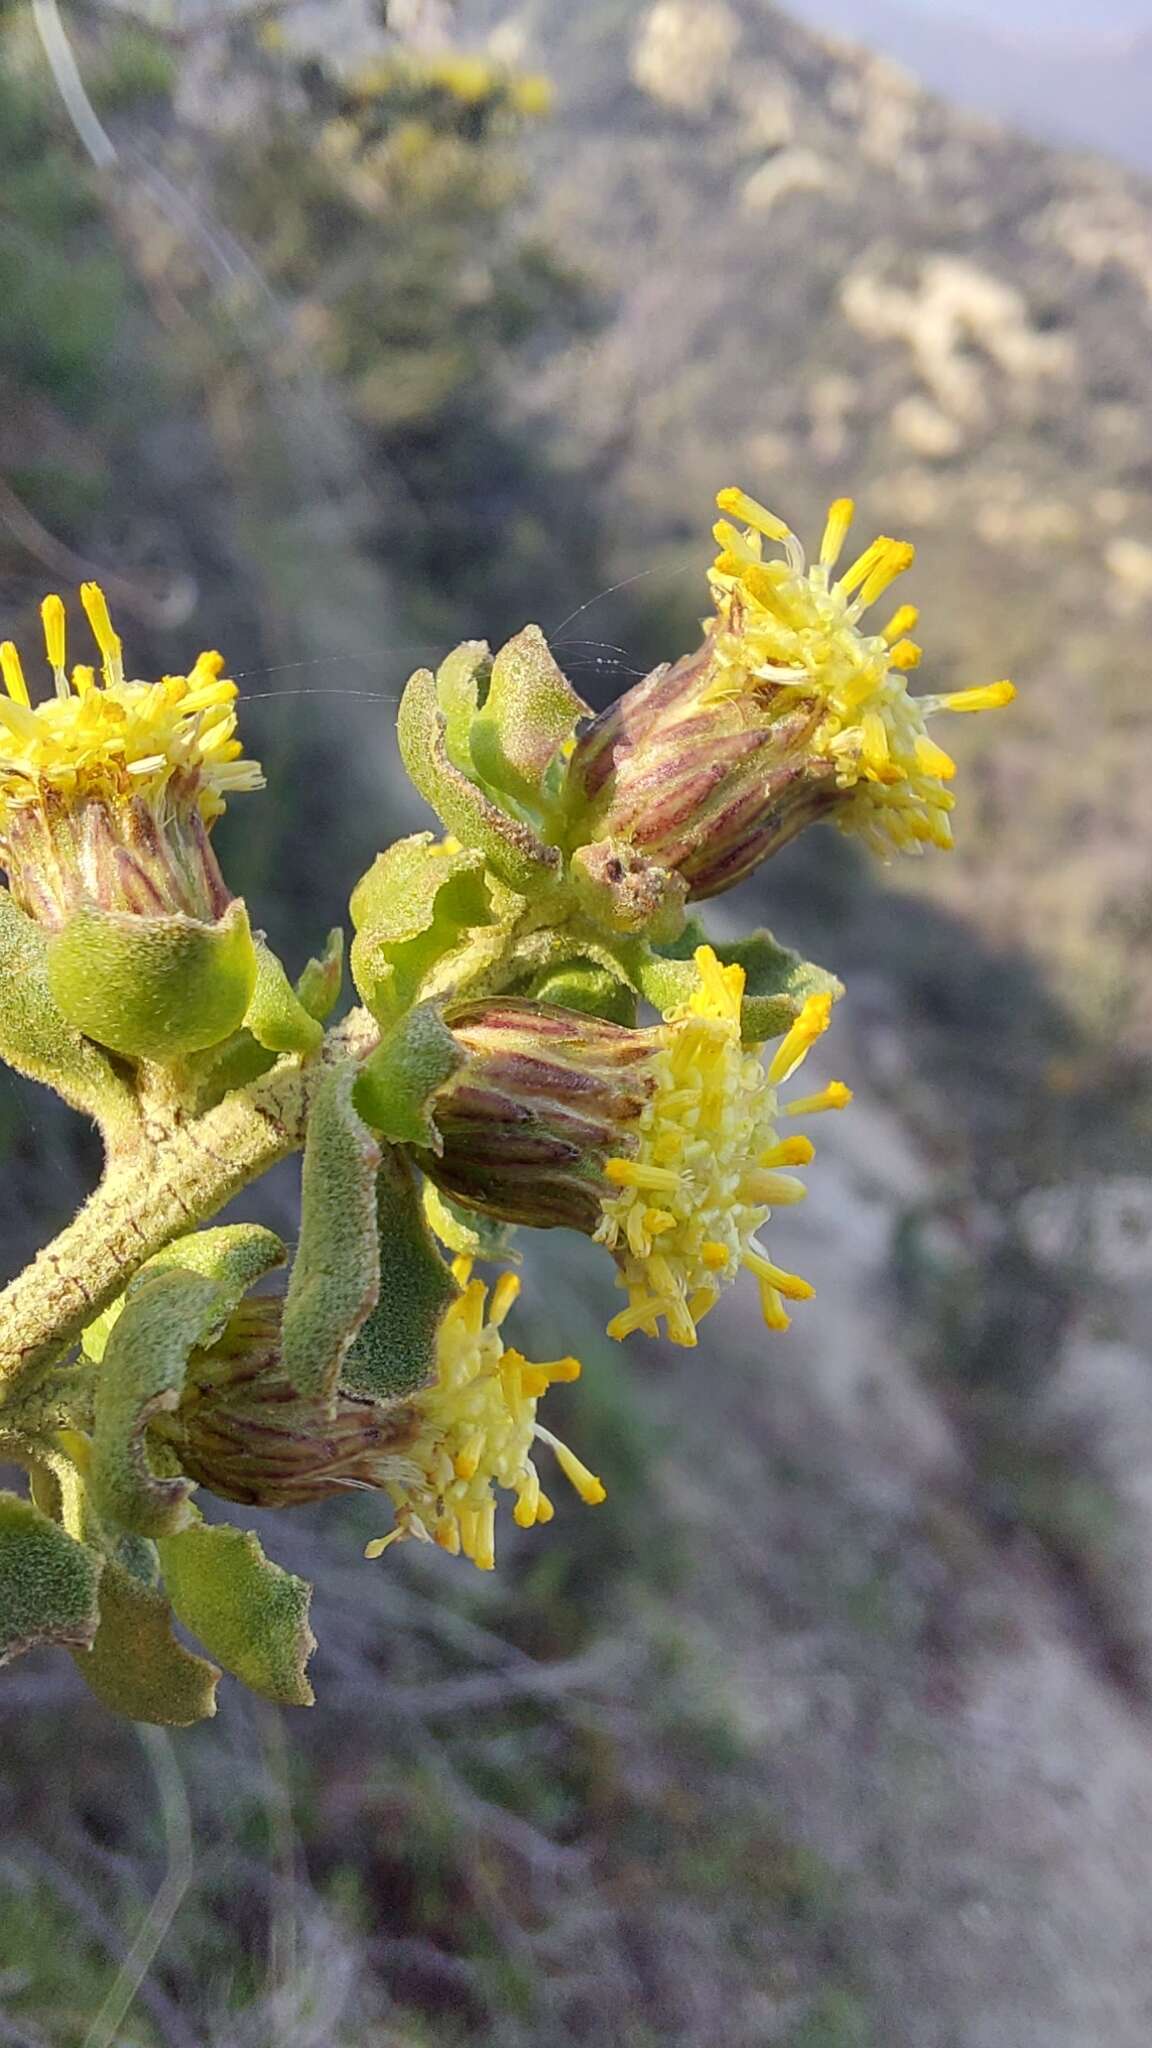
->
<box><xmin>596</xmin><ymin>946</ymin><xmax>851</xmax><ymax>1343</ymax></box>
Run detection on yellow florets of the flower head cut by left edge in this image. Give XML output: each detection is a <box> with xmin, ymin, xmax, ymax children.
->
<box><xmin>0</xmin><ymin>584</ymin><xmax>264</xmax><ymax>821</ymax></box>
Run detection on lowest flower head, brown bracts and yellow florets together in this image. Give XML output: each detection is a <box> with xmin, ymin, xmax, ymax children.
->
<box><xmin>172</xmin><ymin>1260</ymin><xmax>605</xmax><ymax>1571</ymax></box>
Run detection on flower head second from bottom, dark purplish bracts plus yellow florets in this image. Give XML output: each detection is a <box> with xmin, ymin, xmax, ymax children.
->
<box><xmin>420</xmin><ymin>946</ymin><xmax>851</xmax><ymax>1343</ymax></box>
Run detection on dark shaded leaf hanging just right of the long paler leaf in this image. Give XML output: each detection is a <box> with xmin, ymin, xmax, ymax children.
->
<box><xmin>340</xmin><ymin>1149</ymin><xmax>459</xmax><ymax>1401</ymax></box>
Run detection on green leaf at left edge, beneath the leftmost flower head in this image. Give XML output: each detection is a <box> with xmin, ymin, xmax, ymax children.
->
<box><xmin>0</xmin><ymin>889</ymin><xmax>133</xmax><ymax>1118</ymax></box>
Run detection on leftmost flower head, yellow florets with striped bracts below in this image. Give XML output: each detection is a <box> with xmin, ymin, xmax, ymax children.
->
<box><xmin>0</xmin><ymin>584</ymin><xmax>262</xmax><ymax>926</ymax></box>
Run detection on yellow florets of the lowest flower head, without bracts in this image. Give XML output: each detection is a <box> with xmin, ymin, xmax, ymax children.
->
<box><xmin>365</xmin><ymin>1257</ymin><xmax>605</xmax><ymax>1571</ymax></box>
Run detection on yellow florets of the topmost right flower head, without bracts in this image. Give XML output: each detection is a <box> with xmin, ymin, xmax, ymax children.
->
<box><xmin>709</xmin><ymin>489</ymin><xmax>1015</xmax><ymax>854</ymax></box>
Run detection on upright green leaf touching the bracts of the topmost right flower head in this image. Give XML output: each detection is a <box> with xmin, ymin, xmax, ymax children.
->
<box><xmin>471</xmin><ymin>627</ymin><xmax>590</xmax><ymax>805</ymax></box>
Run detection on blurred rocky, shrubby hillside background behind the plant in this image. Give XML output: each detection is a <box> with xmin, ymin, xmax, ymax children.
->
<box><xmin>0</xmin><ymin>0</ymin><xmax>1152</xmax><ymax>2048</ymax></box>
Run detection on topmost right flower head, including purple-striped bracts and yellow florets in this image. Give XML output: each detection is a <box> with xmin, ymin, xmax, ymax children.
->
<box><xmin>570</xmin><ymin>489</ymin><xmax>1015</xmax><ymax>899</ymax></box>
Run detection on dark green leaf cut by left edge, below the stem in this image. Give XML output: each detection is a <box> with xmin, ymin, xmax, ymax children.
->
<box><xmin>0</xmin><ymin>1493</ymin><xmax>102</xmax><ymax>1663</ymax></box>
